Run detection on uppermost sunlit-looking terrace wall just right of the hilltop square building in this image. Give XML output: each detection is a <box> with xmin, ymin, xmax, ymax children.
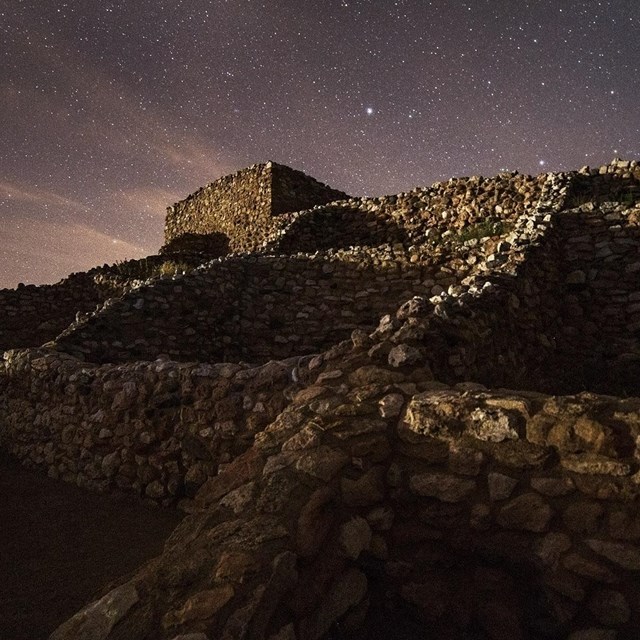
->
<box><xmin>266</xmin><ymin>173</ymin><xmax>546</xmax><ymax>254</ymax></box>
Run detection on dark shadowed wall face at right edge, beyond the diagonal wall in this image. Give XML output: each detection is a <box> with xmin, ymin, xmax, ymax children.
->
<box><xmin>552</xmin><ymin>208</ymin><xmax>640</xmax><ymax>396</ymax></box>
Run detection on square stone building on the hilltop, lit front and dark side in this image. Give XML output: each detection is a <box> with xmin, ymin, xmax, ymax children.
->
<box><xmin>165</xmin><ymin>162</ymin><xmax>347</xmax><ymax>252</ymax></box>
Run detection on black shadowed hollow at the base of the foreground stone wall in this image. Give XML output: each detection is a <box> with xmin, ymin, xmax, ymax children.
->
<box><xmin>325</xmin><ymin>541</ymin><xmax>568</xmax><ymax>640</ymax></box>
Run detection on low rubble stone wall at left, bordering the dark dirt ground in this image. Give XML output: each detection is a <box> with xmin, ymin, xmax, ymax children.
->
<box><xmin>0</xmin><ymin>349</ymin><xmax>304</xmax><ymax>505</ymax></box>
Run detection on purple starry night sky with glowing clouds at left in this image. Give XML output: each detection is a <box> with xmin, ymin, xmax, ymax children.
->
<box><xmin>0</xmin><ymin>0</ymin><xmax>640</xmax><ymax>287</ymax></box>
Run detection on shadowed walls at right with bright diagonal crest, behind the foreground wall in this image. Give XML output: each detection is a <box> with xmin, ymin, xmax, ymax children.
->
<box><xmin>352</xmin><ymin>165</ymin><xmax>640</xmax><ymax>395</ymax></box>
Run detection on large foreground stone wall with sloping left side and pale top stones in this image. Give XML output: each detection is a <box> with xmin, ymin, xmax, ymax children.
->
<box><xmin>38</xmin><ymin>362</ymin><xmax>640</xmax><ymax>640</ymax></box>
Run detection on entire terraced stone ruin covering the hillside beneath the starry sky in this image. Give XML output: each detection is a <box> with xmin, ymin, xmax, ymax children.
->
<box><xmin>0</xmin><ymin>160</ymin><xmax>640</xmax><ymax>640</ymax></box>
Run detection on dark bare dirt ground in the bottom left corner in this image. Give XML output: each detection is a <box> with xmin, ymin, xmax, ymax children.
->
<box><xmin>0</xmin><ymin>453</ymin><xmax>181</xmax><ymax>640</ymax></box>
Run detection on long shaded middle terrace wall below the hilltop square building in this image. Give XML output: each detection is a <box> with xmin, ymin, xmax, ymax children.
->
<box><xmin>56</xmin><ymin>252</ymin><xmax>455</xmax><ymax>363</ymax></box>
